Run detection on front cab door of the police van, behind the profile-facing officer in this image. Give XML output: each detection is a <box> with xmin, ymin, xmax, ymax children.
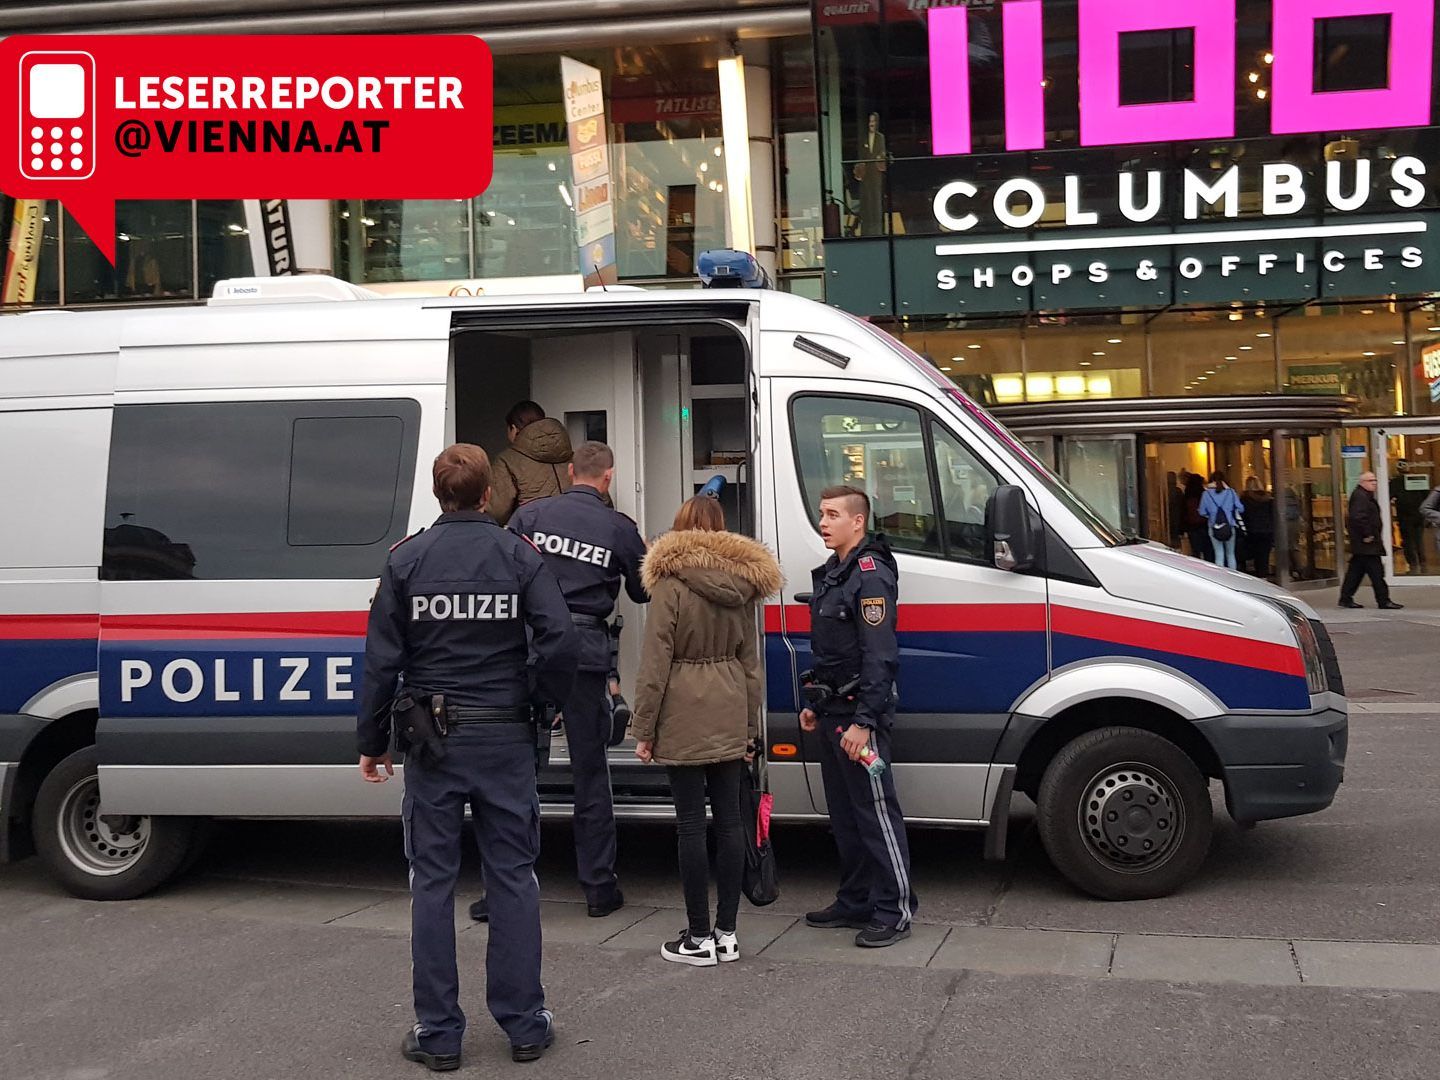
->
<box><xmin>768</xmin><ymin>379</ymin><xmax>1048</xmax><ymax>822</ymax></box>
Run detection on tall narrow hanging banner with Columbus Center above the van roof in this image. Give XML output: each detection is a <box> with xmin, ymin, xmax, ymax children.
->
<box><xmin>560</xmin><ymin>56</ymin><xmax>619</xmax><ymax>287</ymax></box>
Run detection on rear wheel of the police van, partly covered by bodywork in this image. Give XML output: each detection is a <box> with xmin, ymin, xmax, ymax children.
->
<box><xmin>33</xmin><ymin>746</ymin><xmax>196</xmax><ymax>900</ymax></box>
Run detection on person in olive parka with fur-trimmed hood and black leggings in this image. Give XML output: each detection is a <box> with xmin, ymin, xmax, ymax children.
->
<box><xmin>631</xmin><ymin>495</ymin><xmax>780</xmax><ymax>968</ymax></box>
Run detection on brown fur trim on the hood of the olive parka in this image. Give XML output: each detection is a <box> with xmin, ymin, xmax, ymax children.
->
<box><xmin>641</xmin><ymin>528</ymin><xmax>785</xmax><ymax>608</ymax></box>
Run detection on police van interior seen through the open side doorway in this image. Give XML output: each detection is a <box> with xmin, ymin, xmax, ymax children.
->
<box><xmin>446</xmin><ymin>310</ymin><xmax>757</xmax><ymax>804</ymax></box>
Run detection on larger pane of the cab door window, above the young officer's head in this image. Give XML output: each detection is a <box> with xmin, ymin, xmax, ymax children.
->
<box><xmin>791</xmin><ymin>395</ymin><xmax>943</xmax><ymax>554</ymax></box>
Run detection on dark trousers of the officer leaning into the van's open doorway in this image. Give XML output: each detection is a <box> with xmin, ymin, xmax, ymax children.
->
<box><xmin>564</xmin><ymin>665</ymin><xmax>615</xmax><ymax>904</ymax></box>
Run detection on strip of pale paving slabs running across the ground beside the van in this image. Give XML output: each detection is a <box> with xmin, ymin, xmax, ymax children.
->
<box><xmin>11</xmin><ymin>867</ymin><xmax>1440</xmax><ymax>994</ymax></box>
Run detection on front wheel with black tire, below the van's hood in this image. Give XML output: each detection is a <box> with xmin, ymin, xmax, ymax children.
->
<box><xmin>1037</xmin><ymin>727</ymin><xmax>1214</xmax><ymax>900</ymax></box>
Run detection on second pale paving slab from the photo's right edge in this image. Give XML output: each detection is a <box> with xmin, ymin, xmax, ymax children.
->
<box><xmin>1110</xmin><ymin>933</ymin><xmax>1300</xmax><ymax>986</ymax></box>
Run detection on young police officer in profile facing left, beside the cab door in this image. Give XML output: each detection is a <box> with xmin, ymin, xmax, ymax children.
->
<box><xmin>801</xmin><ymin>485</ymin><xmax>919</xmax><ymax>949</ymax></box>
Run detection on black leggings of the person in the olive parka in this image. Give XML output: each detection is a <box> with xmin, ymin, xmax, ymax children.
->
<box><xmin>665</xmin><ymin>762</ymin><xmax>744</xmax><ymax>937</ymax></box>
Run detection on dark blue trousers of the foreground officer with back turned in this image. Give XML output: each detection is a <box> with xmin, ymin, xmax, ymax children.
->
<box><xmin>403</xmin><ymin>723</ymin><xmax>550</xmax><ymax>1054</ymax></box>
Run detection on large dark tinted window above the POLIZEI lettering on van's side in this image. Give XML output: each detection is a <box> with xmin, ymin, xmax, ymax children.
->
<box><xmin>101</xmin><ymin>399</ymin><xmax>420</xmax><ymax>580</ymax></box>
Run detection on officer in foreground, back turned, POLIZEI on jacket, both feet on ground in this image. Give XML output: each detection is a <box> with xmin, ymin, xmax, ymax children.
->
<box><xmin>359</xmin><ymin>444</ymin><xmax>576</xmax><ymax>1071</ymax></box>
